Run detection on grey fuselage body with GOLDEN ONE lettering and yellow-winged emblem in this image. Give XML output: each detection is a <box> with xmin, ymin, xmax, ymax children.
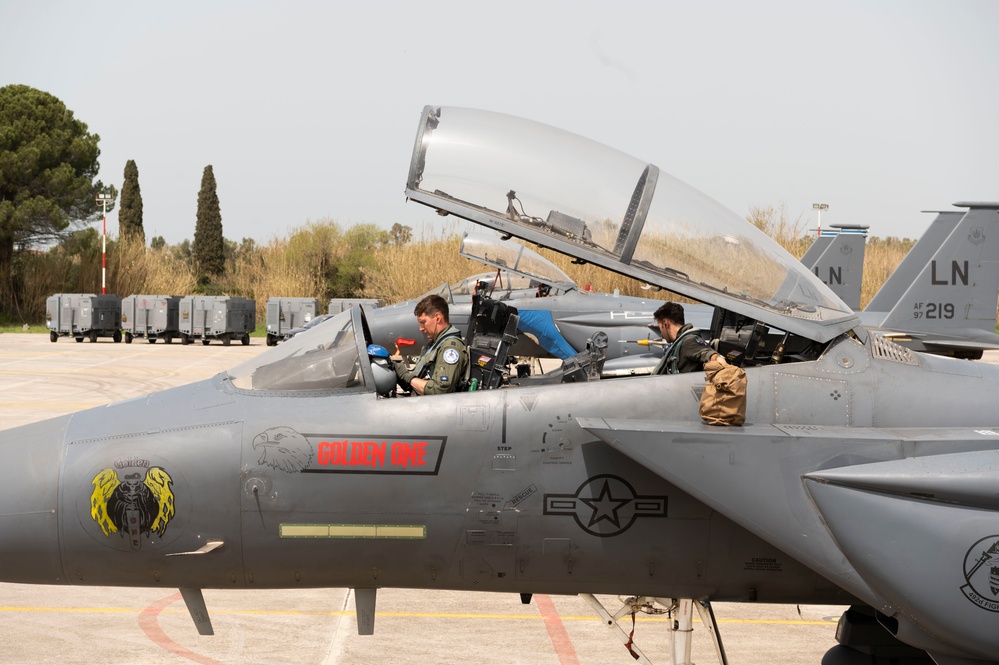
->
<box><xmin>0</xmin><ymin>338</ymin><xmax>999</xmax><ymax>602</ymax></box>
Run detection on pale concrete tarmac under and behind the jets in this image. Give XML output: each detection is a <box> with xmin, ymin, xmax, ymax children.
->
<box><xmin>0</xmin><ymin>333</ymin><xmax>999</xmax><ymax>665</ymax></box>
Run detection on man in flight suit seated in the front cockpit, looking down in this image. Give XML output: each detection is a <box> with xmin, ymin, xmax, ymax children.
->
<box><xmin>392</xmin><ymin>295</ymin><xmax>468</xmax><ymax>395</ymax></box>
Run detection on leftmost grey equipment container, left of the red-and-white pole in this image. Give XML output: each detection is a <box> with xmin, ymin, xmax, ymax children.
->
<box><xmin>45</xmin><ymin>293</ymin><xmax>121</xmax><ymax>342</ymax></box>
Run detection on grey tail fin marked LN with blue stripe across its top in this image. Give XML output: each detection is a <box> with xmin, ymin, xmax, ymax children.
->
<box><xmin>801</xmin><ymin>224</ymin><xmax>867</xmax><ymax>310</ymax></box>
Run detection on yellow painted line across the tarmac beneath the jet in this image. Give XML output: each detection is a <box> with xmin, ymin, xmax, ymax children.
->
<box><xmin>0</xmin><ymin>606</ymin><xmax>837</xmax><ymax>626</ymax></box>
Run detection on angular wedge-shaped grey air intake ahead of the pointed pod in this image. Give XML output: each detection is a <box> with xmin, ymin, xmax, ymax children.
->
<box><xmin>577</xmin><ymin>418</ymin><xmax>900</xmax><ymax>595</ymax></box>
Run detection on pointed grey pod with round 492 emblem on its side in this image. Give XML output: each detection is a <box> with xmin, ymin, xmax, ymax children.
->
<box><xmin>804</xmin><ymin>448</ymin><xmax>999</xmax><ymax>654</ymax></box>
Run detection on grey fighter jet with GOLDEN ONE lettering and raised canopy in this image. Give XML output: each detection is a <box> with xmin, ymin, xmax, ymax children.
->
<box><xmin>0</xmin><ymin>107</ymin><xmax>999</xmax><ymax>665</ymax></box>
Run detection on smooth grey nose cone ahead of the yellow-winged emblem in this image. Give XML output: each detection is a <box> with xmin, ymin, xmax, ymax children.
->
<box><xmin>0</xmin><ymin>416</ymin><xmax>71</xmax><ymax>584</ymax></box>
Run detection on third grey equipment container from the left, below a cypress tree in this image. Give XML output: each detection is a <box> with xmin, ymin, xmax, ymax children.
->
<box><xmin>178</xmin><ymin>296</ymin><xmax>257</xmax><ymax>346</ymax></box>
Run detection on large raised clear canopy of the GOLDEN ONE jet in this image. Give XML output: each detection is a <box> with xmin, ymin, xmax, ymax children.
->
<box><xmin>406</xmin><ymin>106</ymin><xmax>859</xmax><ymax>342</ymax></box>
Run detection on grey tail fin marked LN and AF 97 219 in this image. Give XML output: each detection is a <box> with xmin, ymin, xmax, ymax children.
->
<box><xmin>882</xmin><ymin>203</ymin><xmax>999</xmax><ymax>336</ymax></box>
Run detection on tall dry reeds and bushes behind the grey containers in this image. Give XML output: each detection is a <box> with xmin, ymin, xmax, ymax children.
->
<box><xmin>3</xmin><ymin>214</ymin><xmax>913</xmax><ymax>324</ymax></box>
